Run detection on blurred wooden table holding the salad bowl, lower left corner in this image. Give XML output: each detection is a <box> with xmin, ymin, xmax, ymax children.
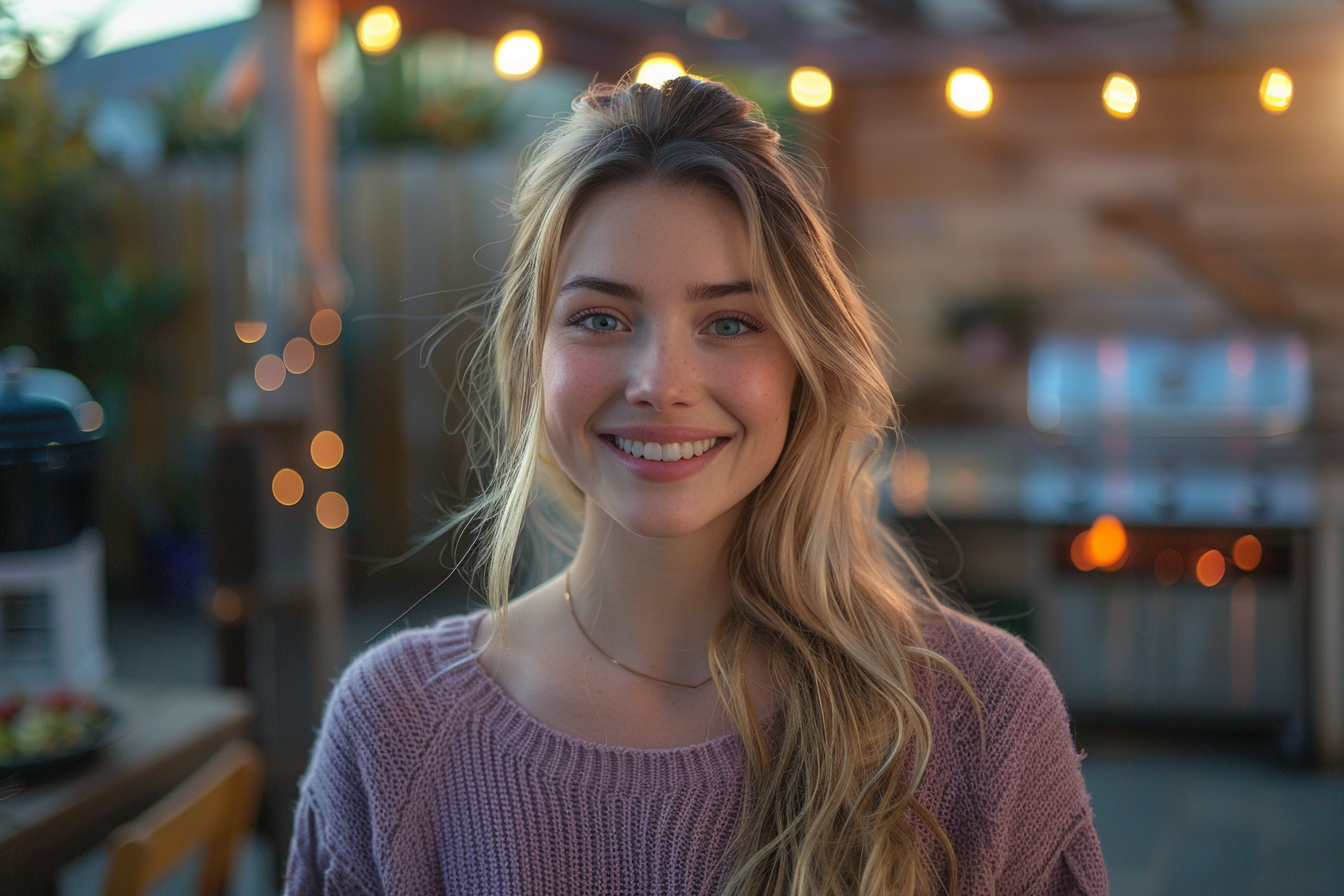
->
<box><xmin>0</xmin><ymin>682</ymin><xmax>253</xmax><ymax>896</ymax></box>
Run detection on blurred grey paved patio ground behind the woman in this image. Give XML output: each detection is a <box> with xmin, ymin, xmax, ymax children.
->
<box><xmin>49</xmin><ymin>602</ymin><xmax>1344</xmax><ymax>896</ymax></box>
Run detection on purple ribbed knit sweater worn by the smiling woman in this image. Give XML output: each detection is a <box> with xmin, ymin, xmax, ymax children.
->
<box><xmin>285</xmin><ymin>610</ymin><xmax>1106</xmax><ymax>896</ymax></box>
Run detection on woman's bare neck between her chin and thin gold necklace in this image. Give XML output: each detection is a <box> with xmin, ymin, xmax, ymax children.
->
<box><xmin>570</xmin><ymin>504</ymin><xmax>737</xmax><ymax>682</ymax></box>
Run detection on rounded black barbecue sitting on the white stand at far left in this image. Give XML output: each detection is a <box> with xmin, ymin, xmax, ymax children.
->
<box><xmin>0</xmin><ymin>345</ymin><xmax>105</xmax><ymax>552</ymax></box>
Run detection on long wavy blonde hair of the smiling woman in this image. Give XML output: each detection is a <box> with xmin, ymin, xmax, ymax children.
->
<box><xmin>431</xmin><ymin>78</ymin><xmax>974</xmax><ymax>896</ymax></box>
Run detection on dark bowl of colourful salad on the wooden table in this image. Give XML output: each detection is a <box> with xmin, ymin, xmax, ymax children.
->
<box><xmin>0</xmin><ymin>688</ymin><xmax>117</xmax><ymax>772</ymax></box>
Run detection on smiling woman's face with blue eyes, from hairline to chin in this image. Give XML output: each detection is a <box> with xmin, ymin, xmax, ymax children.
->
<box><xmin>542</xmin><ymin>181</ymin><xmax>796</xmax><ymax>537</ymax></box>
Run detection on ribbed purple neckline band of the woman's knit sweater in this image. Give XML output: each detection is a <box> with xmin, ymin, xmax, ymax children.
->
<box><xmin>444</xmin><ymin>609</ymin><xmax>758</xmax><ymax>786</ymax></box>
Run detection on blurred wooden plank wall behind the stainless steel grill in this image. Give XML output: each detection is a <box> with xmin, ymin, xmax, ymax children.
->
<box><xmin>817</xmin><ymin>52</ymin><xmax>1344</xmax><ymax>430</ymax></box>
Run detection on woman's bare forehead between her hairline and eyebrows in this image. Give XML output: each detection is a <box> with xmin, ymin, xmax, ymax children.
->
<box><xmin>556</xmin><ymin>181</ymin><xmax>751</xmax><ymax>286</ymax></box>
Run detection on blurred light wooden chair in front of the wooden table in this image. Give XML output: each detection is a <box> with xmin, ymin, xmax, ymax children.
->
<box><xmin>103</xmin><ymin>740</ymin><xmax>262</xmax><ymax>896</ymax></box>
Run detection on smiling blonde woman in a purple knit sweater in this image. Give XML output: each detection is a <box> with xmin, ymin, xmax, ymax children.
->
<box><xmin>280</xmin><ymin>78</ymin><xmax>1106</xmax><ymax>896</ymax></box>
